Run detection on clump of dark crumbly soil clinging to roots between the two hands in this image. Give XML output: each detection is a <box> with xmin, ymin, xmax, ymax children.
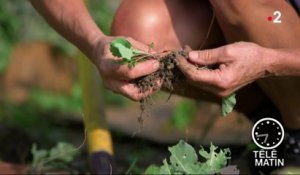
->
<box><xmin>134</xmin><ymin>50</ymin><xmax>188</xmax><ymax>127</ymax></box>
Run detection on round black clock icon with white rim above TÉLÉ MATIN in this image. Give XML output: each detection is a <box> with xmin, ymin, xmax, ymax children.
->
<box><xmin>252</xmin><ymin>118</ymin><xmax>284</xmax><ymax>149</ymax></box>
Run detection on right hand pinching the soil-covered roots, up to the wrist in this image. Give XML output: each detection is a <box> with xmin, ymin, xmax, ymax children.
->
<box><xmin>178</xmin><ymin>42</ymin><xmax>269</xmax><ymax>97</ymax></box>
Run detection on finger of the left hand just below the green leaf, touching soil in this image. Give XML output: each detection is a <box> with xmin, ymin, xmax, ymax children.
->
<box><xmin>110</xmin><ymin>60</ymin><xmax>159</xmax><ymax>81</ymax></box>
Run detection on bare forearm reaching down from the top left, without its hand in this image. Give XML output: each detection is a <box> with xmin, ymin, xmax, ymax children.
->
<box><xmin>31</xmin><ymin>0</ymin><xmax>103</xmax><ymax>61</ymax></box>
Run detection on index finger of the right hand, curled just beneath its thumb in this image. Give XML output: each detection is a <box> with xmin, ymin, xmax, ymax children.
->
<box><xmin>178</xmin><ymin>58</ymin><xmax>220</xmax><ymax>86</ymax></box>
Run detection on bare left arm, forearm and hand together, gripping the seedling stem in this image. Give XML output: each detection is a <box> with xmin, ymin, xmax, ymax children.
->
<box><xmin>31</xmin><ymin>0</ymin><xmax>159</xmax><ymax>100</ymax></box>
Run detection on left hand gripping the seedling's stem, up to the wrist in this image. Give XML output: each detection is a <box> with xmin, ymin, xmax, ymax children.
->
<box><xmin>93</xmin><ymin>36</ymin><xmax>159</xmax><ymax>101</ymax></box>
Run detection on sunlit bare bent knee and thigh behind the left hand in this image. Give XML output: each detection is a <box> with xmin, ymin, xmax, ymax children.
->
<box><xmin>112</xmin><ymin>0</ymin><xmax>264</xmax><ymax>113</ymax></box>
